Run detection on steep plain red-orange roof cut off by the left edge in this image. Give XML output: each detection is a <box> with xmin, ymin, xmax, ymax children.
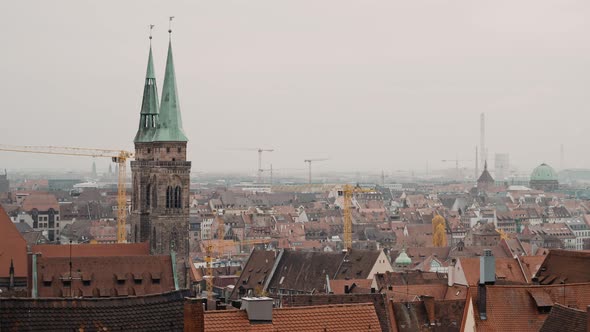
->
<box><xmin>0</xmin><ymin>206</ymin><xmax>28</xmax><ymax>277</ymax></box>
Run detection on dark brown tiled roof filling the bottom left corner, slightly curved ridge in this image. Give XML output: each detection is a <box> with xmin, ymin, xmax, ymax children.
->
<box><xmin>0</xmin><ymin>290</ymin><xmax>190</xmax><ymax>331</ymax></box>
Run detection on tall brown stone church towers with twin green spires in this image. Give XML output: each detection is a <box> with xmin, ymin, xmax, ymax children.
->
<box><xmin>130</xmin><ymin>31</ymin><xmax>191</xmax><ymax>288</ymax></box>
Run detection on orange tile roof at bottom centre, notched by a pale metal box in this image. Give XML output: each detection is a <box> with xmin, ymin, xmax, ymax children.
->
<box><xmin>205</xmin><ymin>303</ymin><xmax>381</xmax><ymax>332</ymax></box>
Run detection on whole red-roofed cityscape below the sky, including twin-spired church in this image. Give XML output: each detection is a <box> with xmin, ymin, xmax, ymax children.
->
<box><xmin>0</xmin><ymin>35</ymin><xmax>590</xmax><ymax>331</ymax></box>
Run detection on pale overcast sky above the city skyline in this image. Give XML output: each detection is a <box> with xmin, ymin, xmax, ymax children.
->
<box><xmin>0</xmin><ymin>0</ymin><xmax>590</xmax><ymax>175</ymax></box>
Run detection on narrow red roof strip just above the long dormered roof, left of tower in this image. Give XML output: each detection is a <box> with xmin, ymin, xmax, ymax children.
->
<box><xmin>33</xmin><ymin>242</ymin><xmax>150</xmax><ymax>257</ymax></box>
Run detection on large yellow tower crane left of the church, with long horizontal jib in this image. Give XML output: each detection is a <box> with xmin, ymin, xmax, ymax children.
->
<box><xmin>0</xmin><ymin>145</ymin><xmax>133</xmax><ymax>243</ymax></box>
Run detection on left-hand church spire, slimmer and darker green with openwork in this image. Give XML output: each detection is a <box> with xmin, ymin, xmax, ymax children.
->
<box><xmin>133</xmin><ymin>43</ymin><xmax>158</xmax><ymax>143</ymax></box>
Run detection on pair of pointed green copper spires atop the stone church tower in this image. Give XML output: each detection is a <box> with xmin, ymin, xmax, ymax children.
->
<box><xmin>134</xmin><ymin>30</ymin><xmax>188</xmax><ymax>143</ymax></box>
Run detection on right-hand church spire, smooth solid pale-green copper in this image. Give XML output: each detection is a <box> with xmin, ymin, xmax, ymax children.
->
<box><xmin>153</xmin><ymin>38</ymin><xmax>188</xmax><ymax>142</ymax></box>
